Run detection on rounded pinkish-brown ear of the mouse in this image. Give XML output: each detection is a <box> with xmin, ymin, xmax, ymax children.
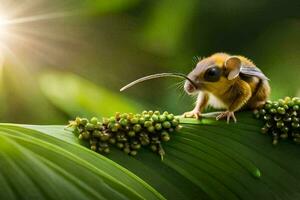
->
<box><xmin>225</xmin><ymin>56</ymin><xmax>242</xmax><ymax>80</ymax></box>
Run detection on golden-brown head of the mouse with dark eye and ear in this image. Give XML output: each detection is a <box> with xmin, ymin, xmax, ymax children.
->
<box><xmin>184</xmin><ymin>53</ymin><xmax>242</xmax><ymax>94</ymax></box>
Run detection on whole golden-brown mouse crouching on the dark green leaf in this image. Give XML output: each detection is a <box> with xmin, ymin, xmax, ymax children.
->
<box><xmin>184</xmin><ymin>53</ymin><xmax>270</xmax><ymax>122</ymax></box>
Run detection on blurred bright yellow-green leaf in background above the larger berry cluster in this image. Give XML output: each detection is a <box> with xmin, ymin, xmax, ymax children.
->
<box><xmin>40</xmin><ymin>72</ymin><xmax>142</xmax><ymax>117</ymax></box>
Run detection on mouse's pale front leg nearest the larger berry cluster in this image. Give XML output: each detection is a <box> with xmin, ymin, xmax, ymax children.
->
<box><xmin>183</xmin><ymin>92</ymin><xmax>209</xmax><ymax>119</ymax></box>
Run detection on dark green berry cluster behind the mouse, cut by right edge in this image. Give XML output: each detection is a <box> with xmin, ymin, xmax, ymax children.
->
<box><xmin>254</xmin><ymin>97</ymin><xmax>300</xmax><ymax>145</ymax></box>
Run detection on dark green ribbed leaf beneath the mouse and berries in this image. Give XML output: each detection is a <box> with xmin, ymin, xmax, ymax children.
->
<box><xmin>19</xmin><ymin>112</ymin><xmax>300</xmax><ymax>199</ymax></box>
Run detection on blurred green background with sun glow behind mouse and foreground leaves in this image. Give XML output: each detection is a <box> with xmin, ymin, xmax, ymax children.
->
<box><xmin>0</xmin><ymin>0</ymin><xmax>300</xmax><ymax>124</ymax></box>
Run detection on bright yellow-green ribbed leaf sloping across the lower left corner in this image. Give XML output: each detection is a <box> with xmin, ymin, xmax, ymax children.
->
<box><xmin>0</xmin><ymin>124</ymin><xmax>163</xmax><ymax>199</ymax></box>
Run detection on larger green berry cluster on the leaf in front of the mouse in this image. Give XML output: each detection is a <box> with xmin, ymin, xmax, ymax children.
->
<box><xmin>69</xmin><ymin>111</ymin><xmax>181</xmax><ymax>158</ymax></box>
